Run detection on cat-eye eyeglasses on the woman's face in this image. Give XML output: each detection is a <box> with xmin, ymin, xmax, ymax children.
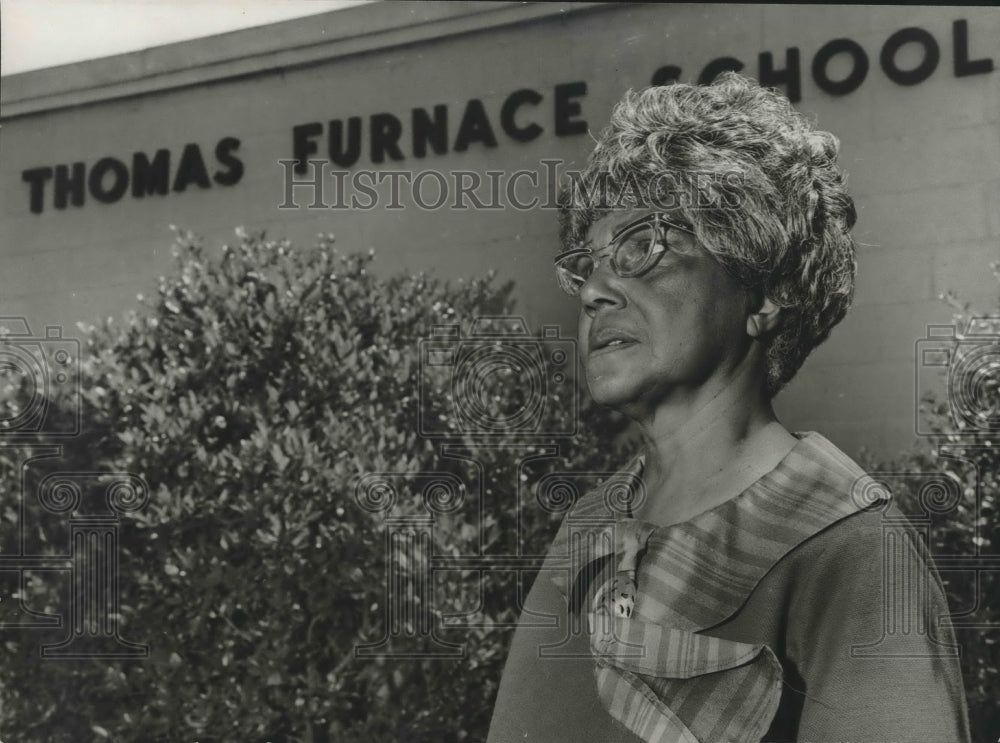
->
<box><xmin>555</xmin><ymin>214</ymin><xmax>694</xmax><ymax>297</ymax></box>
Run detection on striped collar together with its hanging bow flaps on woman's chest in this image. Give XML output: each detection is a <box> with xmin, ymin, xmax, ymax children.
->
<box><xmin>543</xmin><ymin>433</ymin><xmax>884</xmax><ymax>743</ymax></box>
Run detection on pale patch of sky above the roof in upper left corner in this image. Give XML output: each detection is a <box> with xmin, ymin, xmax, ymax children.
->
<box><xmin>0</xmin><ymin>0</ymin><xmax>376</xmax><ymax>75</ymax></box>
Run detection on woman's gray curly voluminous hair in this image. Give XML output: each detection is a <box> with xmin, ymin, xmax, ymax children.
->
<box><xmin>559</xmin><ymin>73</ymin><xmax>857</xmax><ymax>397</ymax></box>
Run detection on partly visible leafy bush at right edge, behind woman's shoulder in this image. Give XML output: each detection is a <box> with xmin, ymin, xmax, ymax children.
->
<box><xmin>867</xmin><ymin>280</ymin><xmax>1000</xmax><ymax>743</ymax></box>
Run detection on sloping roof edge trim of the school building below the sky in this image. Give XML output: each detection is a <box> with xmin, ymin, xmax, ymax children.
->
<box><xmin>0</xmin><ymin>2</ymin><xmax>611</xmax><ymax>119</ymax></box>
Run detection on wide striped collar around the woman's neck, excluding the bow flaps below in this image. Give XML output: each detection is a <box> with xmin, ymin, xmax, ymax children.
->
<box><xmin>545</xmin><ymin>432</ymin><xmax>883</xmax><ymax>631</ymax></box>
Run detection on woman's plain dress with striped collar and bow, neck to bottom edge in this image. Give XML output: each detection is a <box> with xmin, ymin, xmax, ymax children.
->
<box><xmin>489</xmin><ymin>434</ymin><xmax>968</xmax><ymax>743</ymax></box>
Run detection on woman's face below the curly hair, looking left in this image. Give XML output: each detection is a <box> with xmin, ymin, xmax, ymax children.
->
<box><xmin>579</xmin><ymin>209</ymin><xmax>751</xmax><ymax>418</ymax></box>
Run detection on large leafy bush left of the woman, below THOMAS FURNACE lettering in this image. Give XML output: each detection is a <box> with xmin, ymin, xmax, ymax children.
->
<box><xmin>0</xmin><ymin>232</ymin><xmax>620</xmax><ymax>743</ymax></box>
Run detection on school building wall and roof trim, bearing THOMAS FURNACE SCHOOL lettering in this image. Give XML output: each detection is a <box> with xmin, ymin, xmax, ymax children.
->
<box><xmin>0</xmin><ymin>3</ymin><xmax>1000</xmax><ymax>453</ymax></box>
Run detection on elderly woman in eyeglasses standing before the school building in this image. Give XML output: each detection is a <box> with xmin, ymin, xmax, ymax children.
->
<box><xmin>489</xmin><ymin>74</ymin><xmax>969</xmax><ymax>743</ymax></box>
